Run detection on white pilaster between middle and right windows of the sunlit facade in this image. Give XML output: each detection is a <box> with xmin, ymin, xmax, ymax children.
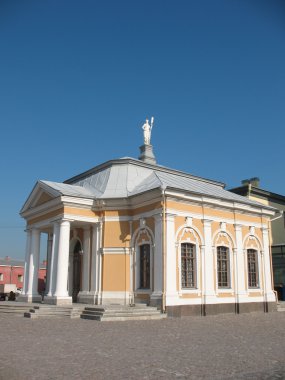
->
<box><xmin>234</xmin><ymin>224</ymin><xmax>246</xmax><ymax>302</ymax></box>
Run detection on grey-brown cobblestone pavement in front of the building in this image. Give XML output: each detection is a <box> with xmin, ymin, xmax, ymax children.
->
<box><xmin>0</xmin><ymin>312</ymin><xmax>285</xmax><ymax>380</ymax></box>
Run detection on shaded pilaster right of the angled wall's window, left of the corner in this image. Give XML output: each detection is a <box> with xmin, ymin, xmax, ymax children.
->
<box><xmin>151</xmin><ymin>213</ymin><xmax>163</xmax><ymax>304</ymax></box>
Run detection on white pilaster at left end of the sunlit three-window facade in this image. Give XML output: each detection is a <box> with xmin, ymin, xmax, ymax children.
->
<box><xmin>165</xmin><ymin>214</ymin><xmax>177</xmax><ymax>306</ymax></box>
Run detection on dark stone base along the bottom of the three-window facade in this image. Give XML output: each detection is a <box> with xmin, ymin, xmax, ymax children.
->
<box><xmin>166</xmin><ymin>302</ymin><xmax>276</xmax><ymax>318</ymax></box>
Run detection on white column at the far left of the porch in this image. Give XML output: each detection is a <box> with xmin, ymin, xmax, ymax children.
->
<box><xmin>26</xmin><ymin>228</ymin><xmax>41</xmax><ymax>302</ymax></box>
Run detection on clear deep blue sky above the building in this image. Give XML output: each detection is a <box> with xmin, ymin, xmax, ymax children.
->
<box><xmin>0</xmin><ymin>0</ymin><xmax>285</xmax><ymax>258</ymax></box>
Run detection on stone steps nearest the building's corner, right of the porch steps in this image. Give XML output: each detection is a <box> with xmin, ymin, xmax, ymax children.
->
<box><xmin>80</xmin><ymin>304</ymin><xmax>167</xmax><ymax>322</ymax></box>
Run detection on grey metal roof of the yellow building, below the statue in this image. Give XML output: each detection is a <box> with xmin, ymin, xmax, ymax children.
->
<box><xmin>30</xmin><ymin>158</ymin><xmax>272</xmax><ymax>209</ymax></box>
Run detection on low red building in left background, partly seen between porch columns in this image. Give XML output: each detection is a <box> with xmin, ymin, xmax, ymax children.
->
<box><xmin>0</xmin><ymin>256</ymin><xmax>46</xmax><ymax>294</ymax></box>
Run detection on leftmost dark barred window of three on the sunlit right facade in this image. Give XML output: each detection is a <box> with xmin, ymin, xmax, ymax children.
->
<box><xmin>181</xmin><ymin>243</ymin><xmax>197</xmax><ymax>289</ymax></box>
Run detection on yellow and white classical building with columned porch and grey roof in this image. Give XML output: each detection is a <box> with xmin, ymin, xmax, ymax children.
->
<box><xmin>18</xmin><ymin>124</ymin><xmax>276</xmax><ymax>316</ymax></box>
